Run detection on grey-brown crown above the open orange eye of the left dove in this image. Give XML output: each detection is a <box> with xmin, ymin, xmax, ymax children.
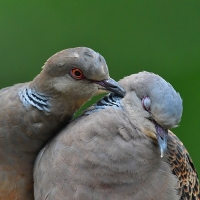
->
<box><xmin>43</xmin><ymin>47</ymin><xmax>109</xmax><ymax>81</ymax></box>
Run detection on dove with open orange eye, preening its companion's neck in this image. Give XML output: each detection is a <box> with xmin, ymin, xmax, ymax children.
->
<box><xmin>0</xmin><ymin>47</ymin><xmax>124</xmax><ymax>200</ymax></box>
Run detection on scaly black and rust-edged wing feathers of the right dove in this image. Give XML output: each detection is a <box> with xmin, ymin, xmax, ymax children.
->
<box><xmin>167</xmin><ymin>132</ymin><xmax>200</xmax><ymax>200</ymax></box>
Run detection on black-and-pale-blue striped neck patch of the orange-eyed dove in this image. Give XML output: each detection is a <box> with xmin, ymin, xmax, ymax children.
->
<box><xmin>19</xmin><ymin>88</ymin><xmax>51</xmax><ymax>112</ymax></box>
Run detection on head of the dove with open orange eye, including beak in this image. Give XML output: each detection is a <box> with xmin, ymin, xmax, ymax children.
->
<box><xmin>39</xmin><ymin>47</ymin><xmax>125</xmax><ymax>97</ymax></box>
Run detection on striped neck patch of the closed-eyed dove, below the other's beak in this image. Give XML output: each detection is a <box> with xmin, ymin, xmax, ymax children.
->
<box><xmin>84</xmin><ymin>93</ymin><xmax>122</xmax><ymax>115</ymax></box>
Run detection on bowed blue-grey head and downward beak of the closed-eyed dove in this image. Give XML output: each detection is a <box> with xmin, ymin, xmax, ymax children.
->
<box><xmin>120</xmin><ymin>71</ymin><xmax>183</xmax><ymax>157</ymax></box>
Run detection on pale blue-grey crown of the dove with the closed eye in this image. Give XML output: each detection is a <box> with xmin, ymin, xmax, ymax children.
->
<box><xmin>120</xmin><ymin>71</ymin><xmax>183</xmax><ymax>129</ymax></box>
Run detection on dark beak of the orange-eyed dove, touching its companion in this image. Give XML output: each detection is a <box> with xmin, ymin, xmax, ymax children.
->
<box><xmin>94</xmin><ymin>78</ymin><xmax>126</xmax><ymax>97</ymax></box>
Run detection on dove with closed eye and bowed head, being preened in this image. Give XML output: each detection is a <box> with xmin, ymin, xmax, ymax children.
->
<box><xmin>34</xmin><ymin>72</ymin><xmax>199</xmax><ymax>200</ymax></box>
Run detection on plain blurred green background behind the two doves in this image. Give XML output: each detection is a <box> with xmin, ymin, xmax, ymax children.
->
<box><xmin>0</xmin><ymin>0</ymin><xmax>200</xmax><ymax>173</ymax></box>
